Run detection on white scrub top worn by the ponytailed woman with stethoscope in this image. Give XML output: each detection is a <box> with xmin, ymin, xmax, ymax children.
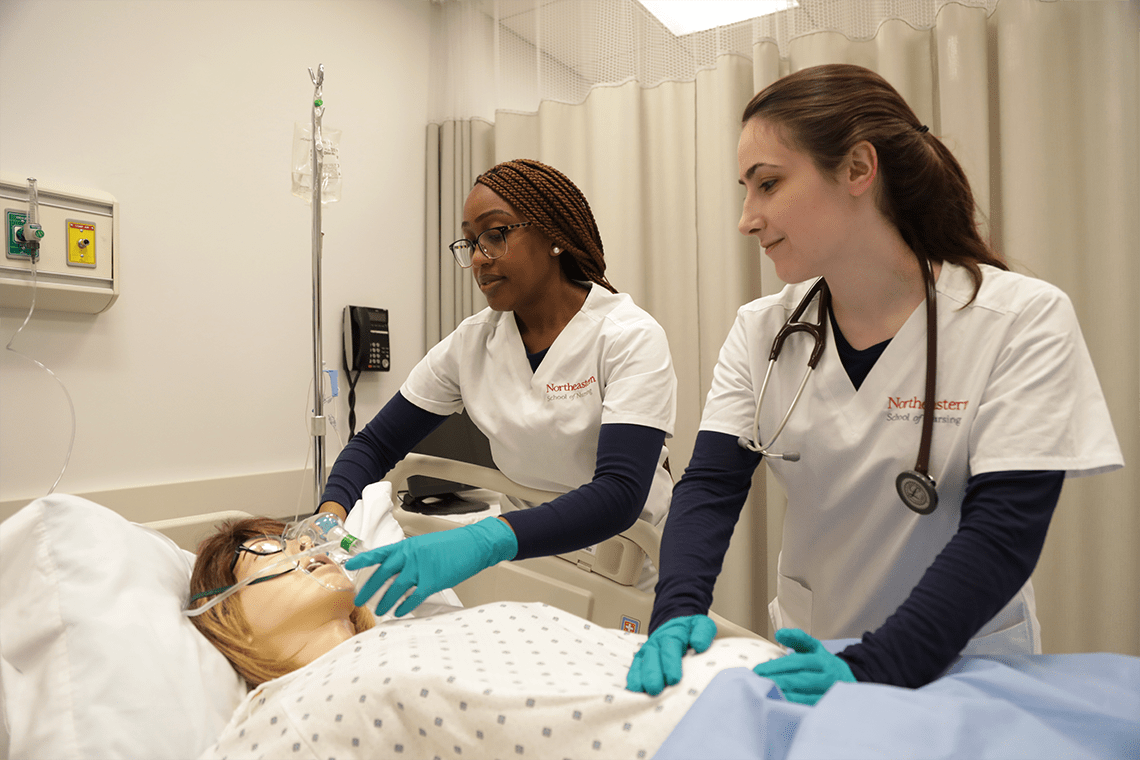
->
<box><xmin>701</xmin><ymin>264</ymin><xmax>1123</xmax><ymax>654</ymax></box>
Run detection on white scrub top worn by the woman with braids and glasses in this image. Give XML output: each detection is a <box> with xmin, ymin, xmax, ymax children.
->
<box><xmin>400</xmin><ymin>286</ymin><xmax>677</xmax><ymax>525</ymax></box>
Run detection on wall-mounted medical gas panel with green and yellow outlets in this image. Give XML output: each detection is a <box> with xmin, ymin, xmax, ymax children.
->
<box><xmin>0</xmin><ymin>172</ymin><xmax>120</xmax><ymax>314</ymax></box>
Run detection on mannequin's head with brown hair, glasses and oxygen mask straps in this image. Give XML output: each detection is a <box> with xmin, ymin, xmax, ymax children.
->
<box><xmin>190</xmin><ymin>517</ymin><xmax>374</xmax><ymax>687</ymax></box>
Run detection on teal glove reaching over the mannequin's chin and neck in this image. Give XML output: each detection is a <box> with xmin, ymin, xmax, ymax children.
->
<box><xmin>344</xmin><ymin>517</ymin><xmax>519</xmax><ymax>618</ymax></box>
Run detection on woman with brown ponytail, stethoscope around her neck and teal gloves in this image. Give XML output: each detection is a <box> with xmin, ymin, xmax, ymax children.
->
<box><xmin>627</xmin><ymin>65</ymin><xmax>1123</xmax><ymax>704</ymax></box>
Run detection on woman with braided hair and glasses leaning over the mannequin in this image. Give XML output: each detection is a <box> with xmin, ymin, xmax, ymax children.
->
<box><xmin>320</xmin><ymin>160</ymin><xmax>676</xmax><ymax>615</ymax></box>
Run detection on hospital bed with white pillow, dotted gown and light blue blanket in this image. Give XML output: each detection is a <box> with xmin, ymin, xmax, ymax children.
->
<box><xmin>0</xmin><ymin>455</ymin><xmax>1140</xmax><ymax>760</ymax></box>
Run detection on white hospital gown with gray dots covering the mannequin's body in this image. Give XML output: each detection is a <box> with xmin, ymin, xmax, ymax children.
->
<box><xmin>202</xmin><ymin>603</ymin><xmax>781</xmax><ymax>760</ymax></box>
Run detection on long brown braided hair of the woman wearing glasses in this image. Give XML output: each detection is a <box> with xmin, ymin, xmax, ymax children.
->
<box><xmin>475</xmin><ymin>158</ymin><xmax>618</xmax><ymax>293</ymax></box>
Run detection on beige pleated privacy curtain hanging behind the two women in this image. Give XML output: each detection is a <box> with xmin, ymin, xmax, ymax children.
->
<box><xmin>428</xmin><ymin>0</ymin><xmax>1140</xmax><ymax>655</ymax></box>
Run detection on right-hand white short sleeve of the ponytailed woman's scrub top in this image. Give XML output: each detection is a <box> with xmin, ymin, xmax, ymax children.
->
<box><xmin>960</xmin><ymin>287</ymin><xmax>1123</xmax><ymax>477</ymax></box>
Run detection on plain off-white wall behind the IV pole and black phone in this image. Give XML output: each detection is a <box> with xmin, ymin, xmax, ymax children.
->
<box><xmin>0</xmin><ymin>0</ymin><xmax>430</xmax><ymax>517</ymax></box>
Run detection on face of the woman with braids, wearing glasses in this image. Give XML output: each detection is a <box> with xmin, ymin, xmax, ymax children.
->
<box><xmin>463</xmin><ymin>185</ymin><xmax>563</xmax><ymax>311</ymax></box>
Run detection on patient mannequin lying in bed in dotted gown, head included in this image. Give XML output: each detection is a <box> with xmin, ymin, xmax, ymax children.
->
<box><xmin>190</xmin><ymin>517</ymin><xmax>781</xmax><ymax>760</ymax></box>
